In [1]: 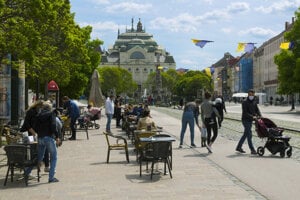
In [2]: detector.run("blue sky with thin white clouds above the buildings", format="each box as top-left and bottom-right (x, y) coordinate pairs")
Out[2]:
(70, 0), (300, 70)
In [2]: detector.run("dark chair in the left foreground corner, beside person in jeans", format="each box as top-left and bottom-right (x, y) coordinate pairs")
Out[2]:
(4, 145), (40, 186)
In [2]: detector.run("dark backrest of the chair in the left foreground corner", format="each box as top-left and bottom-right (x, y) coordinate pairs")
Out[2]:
(4, 145), (30, 165)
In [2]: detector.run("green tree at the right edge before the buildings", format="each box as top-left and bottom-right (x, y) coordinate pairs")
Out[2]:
(274, 8), (300, 110)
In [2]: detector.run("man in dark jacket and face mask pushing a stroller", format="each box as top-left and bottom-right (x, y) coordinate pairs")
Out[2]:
(236, 89), (261, 154)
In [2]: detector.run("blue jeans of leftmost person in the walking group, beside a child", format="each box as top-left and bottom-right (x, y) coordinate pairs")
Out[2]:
(180, 111), (195, 145)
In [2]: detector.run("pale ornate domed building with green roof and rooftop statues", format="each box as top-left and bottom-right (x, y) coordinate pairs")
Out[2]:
(100, 19), (176, 95)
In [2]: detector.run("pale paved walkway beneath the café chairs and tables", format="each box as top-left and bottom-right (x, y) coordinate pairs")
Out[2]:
(0, 105), (300, 200)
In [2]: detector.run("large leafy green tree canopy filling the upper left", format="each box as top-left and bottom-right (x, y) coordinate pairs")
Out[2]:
(0, 0), (103, 98)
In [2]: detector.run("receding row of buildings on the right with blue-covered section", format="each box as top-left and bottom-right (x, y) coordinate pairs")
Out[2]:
(214, 18), (299, 102)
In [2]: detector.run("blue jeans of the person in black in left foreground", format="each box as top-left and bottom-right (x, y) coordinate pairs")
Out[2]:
(38, 136), (57, 181)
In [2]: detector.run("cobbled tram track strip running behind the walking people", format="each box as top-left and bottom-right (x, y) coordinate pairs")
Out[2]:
(153, 103), (300, 162)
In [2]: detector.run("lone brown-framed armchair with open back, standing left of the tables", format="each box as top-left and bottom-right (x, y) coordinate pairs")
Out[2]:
(103, 132), (129, 163)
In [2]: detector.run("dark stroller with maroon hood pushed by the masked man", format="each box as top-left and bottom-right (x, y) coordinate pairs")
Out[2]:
(255, 118), (292, 158)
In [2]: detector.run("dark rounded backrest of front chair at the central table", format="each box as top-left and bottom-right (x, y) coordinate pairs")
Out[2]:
(145, 141), (171, 160)
